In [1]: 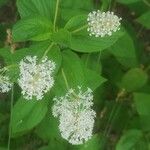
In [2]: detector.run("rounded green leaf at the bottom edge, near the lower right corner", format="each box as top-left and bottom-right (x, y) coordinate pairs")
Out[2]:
(116, 129), (143, 150)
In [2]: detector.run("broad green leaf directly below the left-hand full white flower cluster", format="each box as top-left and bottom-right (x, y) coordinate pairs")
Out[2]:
(11, 98), (48, 137)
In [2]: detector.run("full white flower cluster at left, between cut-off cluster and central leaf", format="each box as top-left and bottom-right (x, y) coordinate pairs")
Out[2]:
(18, 56), (55, 100)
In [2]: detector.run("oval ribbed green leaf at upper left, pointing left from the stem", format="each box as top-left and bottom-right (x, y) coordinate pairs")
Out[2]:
(13, 16), (53, 42)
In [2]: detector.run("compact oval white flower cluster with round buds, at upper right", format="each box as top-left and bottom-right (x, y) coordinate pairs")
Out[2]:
(87, 10), (121, 37)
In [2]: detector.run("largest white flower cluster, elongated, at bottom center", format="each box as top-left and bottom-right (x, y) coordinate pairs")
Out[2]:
(52, 87), (96, 145)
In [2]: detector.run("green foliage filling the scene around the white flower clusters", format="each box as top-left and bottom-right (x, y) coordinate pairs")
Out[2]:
(0, 0), (150, 150)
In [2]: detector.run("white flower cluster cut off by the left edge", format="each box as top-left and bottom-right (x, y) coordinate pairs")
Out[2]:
(0, 68), (12, 93)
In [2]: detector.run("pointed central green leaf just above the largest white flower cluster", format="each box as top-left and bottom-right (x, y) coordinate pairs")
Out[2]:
(55, 50), (106, 94)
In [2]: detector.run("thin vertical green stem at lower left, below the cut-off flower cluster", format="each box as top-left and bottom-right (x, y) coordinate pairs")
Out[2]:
(7, 85), (14, 150)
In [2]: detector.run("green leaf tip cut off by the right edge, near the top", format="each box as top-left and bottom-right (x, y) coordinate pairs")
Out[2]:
(136, 11), (150, 29)
